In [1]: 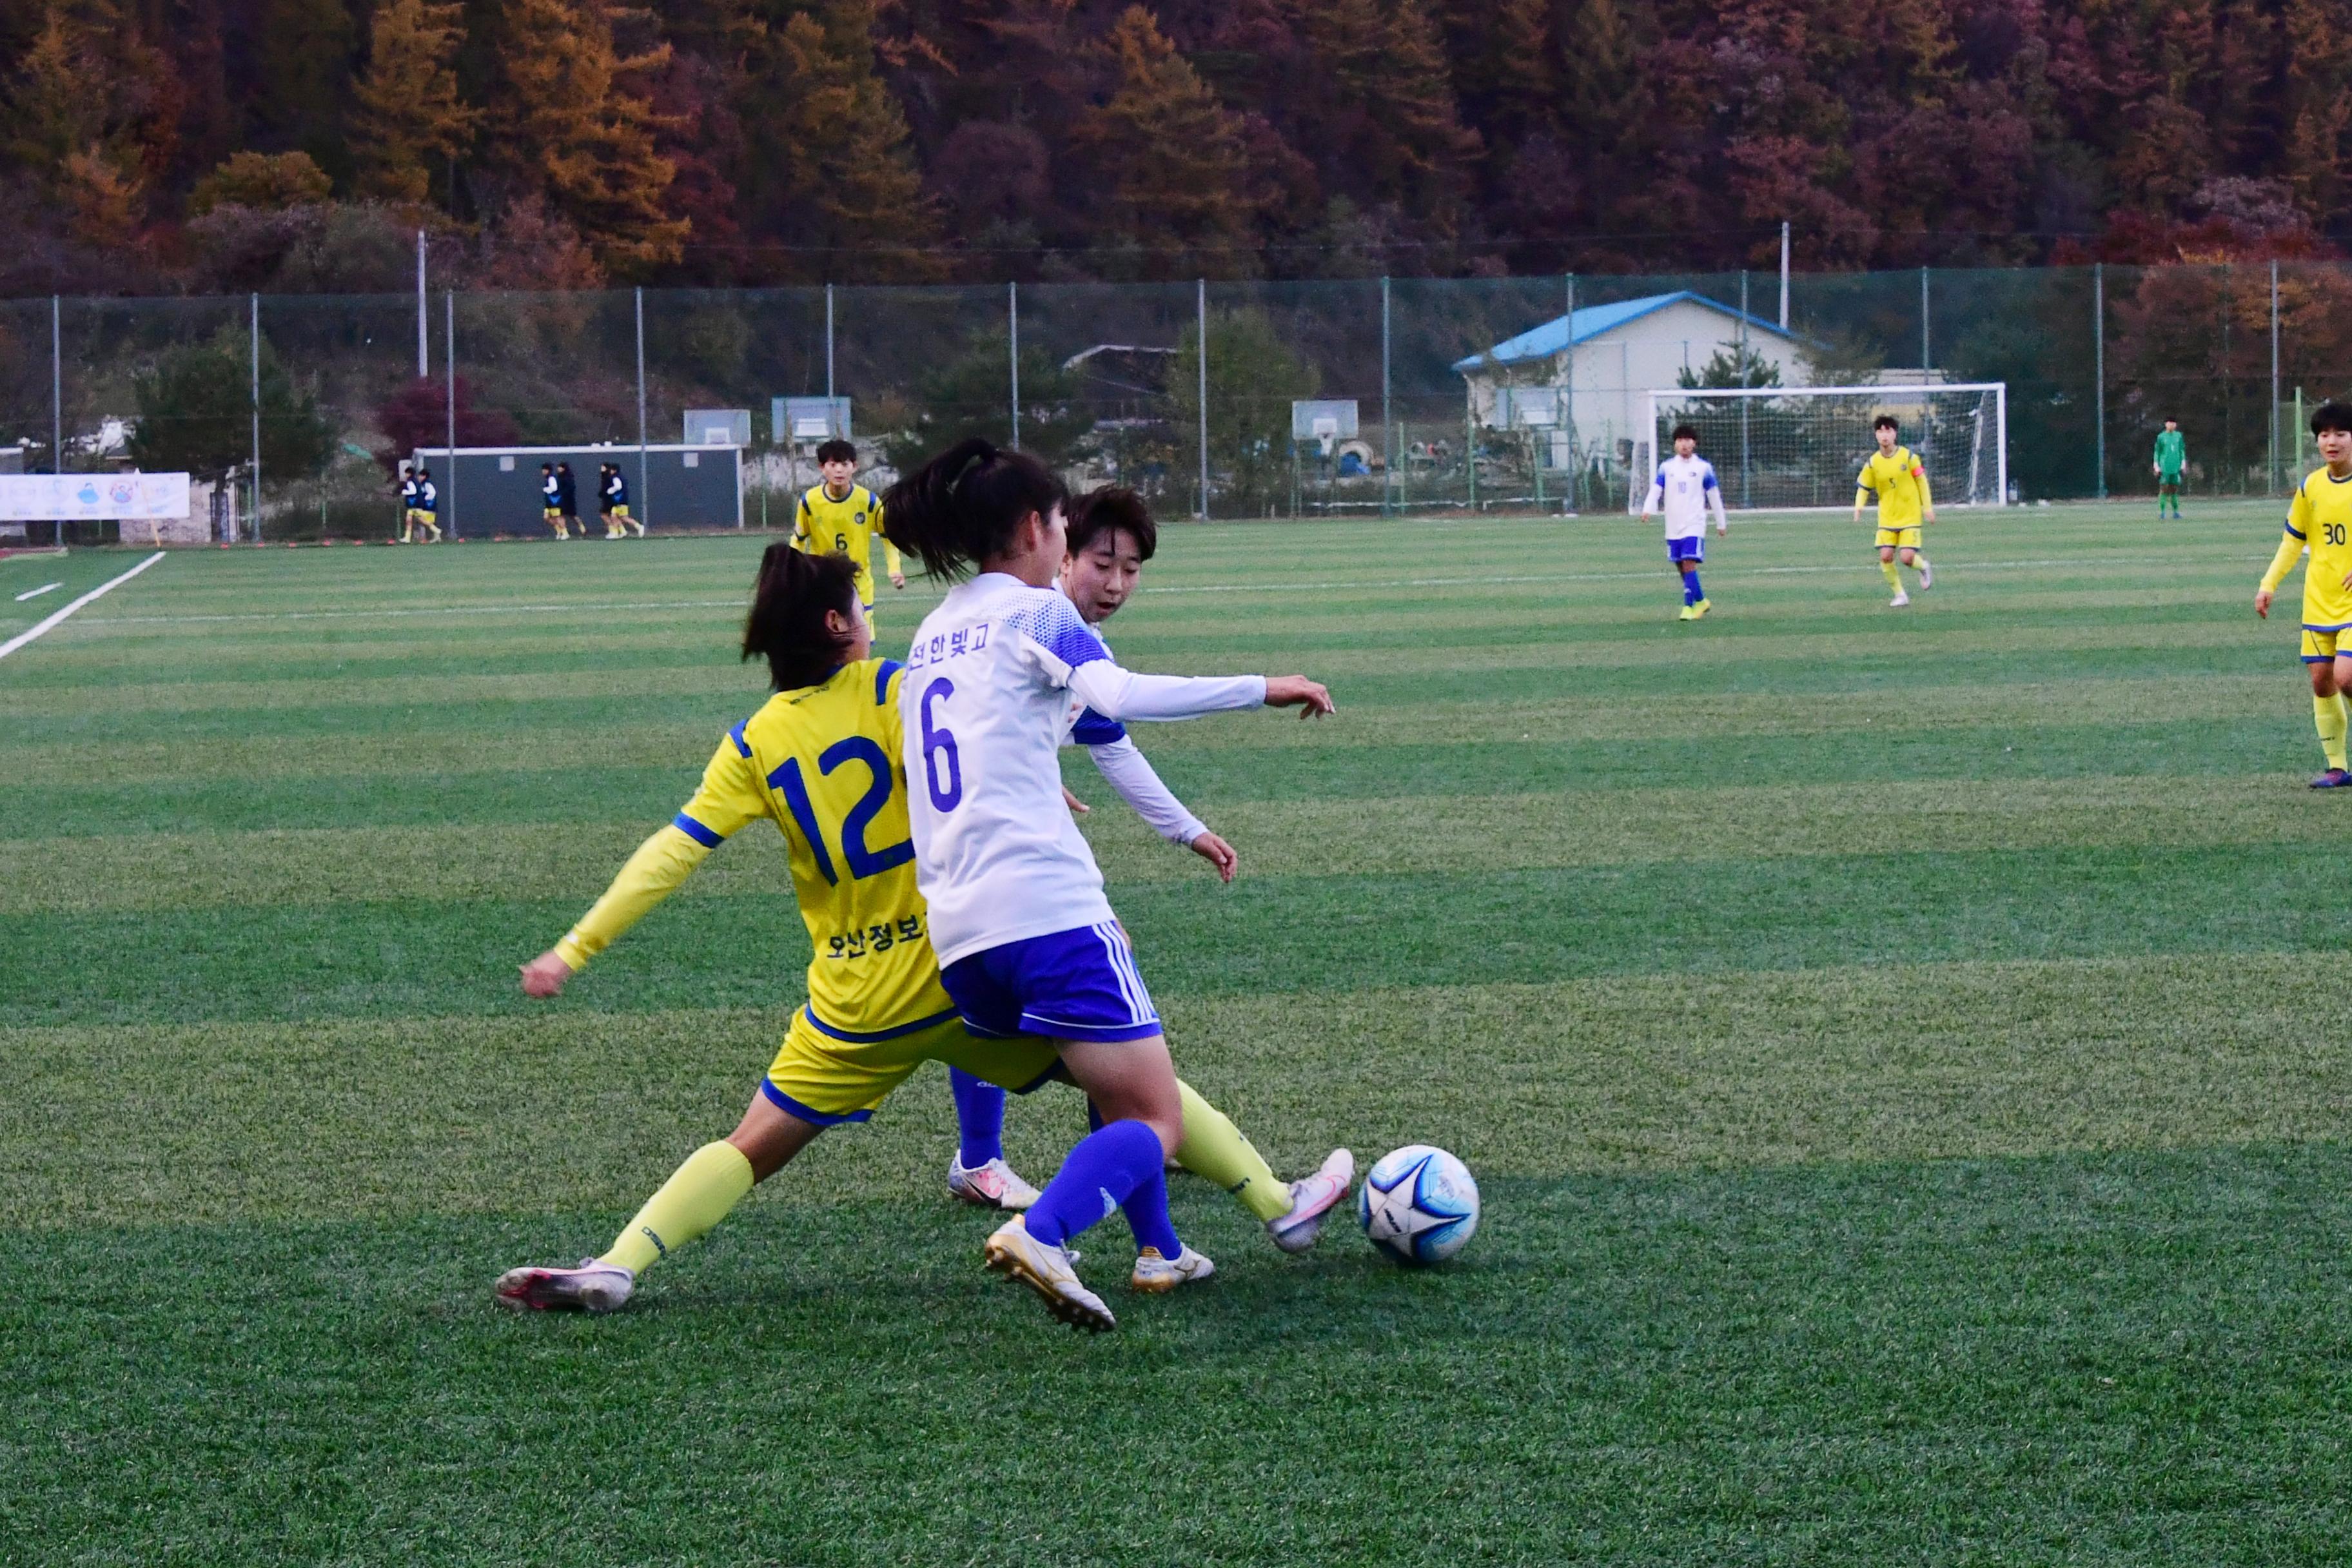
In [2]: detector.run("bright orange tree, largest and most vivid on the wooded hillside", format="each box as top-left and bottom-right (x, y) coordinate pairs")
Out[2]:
(496, 0), (692, 275)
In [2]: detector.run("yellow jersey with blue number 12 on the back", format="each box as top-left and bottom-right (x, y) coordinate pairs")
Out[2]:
(555, 658), (955, 1039)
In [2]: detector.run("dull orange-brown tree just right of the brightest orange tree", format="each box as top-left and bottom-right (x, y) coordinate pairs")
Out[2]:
(767, 0), (939, 277)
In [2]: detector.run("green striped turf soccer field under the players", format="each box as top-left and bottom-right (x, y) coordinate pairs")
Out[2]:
(0, 503), (2352, 1568)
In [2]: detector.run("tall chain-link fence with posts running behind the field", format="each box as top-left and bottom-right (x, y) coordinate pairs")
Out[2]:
(0, 263), (2352, 541)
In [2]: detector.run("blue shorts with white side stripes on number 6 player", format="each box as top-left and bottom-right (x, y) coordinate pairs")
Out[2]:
(939, 921), (1162, 1041)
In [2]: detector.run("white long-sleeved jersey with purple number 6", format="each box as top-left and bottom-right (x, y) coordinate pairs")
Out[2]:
(899, 571), (1266, 966)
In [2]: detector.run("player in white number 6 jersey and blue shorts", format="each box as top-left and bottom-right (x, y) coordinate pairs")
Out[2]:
(882, 440), (1353, 1331)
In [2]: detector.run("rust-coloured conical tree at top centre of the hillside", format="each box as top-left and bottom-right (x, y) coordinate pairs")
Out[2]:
(1072, 5), (1256, 275)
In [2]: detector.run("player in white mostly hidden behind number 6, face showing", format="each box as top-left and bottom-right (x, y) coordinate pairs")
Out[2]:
(948, 484), (1279, 1213)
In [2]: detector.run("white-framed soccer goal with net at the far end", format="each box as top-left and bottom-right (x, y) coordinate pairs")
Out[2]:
(1627, 381), (2008, 513)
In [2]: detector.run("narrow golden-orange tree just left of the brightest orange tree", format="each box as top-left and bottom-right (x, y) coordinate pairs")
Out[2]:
(353, 0), (478, 202)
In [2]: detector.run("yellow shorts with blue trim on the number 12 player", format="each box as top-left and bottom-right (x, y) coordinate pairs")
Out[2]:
(760, 1008), (1061, 1126)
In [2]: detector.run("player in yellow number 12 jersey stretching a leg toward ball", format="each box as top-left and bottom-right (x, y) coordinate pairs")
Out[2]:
(496, 543), (1336, 1312)
